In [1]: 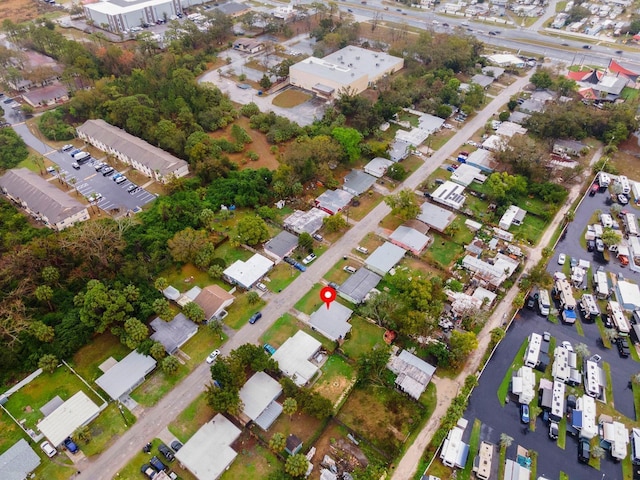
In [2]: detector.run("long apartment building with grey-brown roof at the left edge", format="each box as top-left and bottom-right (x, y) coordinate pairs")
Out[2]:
(0, 168), (89, 230)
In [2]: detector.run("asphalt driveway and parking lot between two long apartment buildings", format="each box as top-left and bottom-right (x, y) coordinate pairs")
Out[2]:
(0, 102), (156, 212)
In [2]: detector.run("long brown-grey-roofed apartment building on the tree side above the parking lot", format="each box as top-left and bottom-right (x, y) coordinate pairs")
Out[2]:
(77, 119), (189, 183)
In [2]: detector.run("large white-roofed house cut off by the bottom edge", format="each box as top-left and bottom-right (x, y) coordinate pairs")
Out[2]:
(176, 413), (242, 480)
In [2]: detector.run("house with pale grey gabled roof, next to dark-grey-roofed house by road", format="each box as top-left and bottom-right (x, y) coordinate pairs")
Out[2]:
(96, 350), (156, 400)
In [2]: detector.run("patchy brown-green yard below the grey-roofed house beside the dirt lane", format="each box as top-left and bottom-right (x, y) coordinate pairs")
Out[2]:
(338, 386), (425, 458)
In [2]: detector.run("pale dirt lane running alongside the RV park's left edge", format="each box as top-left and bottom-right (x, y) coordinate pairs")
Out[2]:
(391, 149), (602, 480)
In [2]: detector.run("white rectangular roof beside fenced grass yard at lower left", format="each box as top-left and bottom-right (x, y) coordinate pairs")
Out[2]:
(38, 391), (100, 447)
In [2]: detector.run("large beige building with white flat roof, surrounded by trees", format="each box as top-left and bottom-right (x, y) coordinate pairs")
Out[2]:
(289, 46), (404, 98)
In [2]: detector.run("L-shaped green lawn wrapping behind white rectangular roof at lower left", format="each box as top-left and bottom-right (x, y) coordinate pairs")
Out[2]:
(4, 366), (102, 429)
